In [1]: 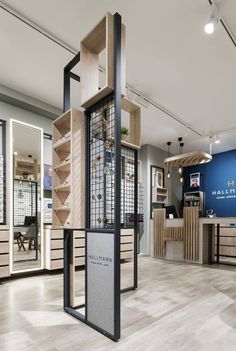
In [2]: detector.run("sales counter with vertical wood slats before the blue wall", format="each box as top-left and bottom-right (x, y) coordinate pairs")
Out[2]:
(150, 207), (236, 264)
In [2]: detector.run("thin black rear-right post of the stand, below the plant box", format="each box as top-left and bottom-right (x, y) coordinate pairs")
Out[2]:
(134, 150), (138, 289)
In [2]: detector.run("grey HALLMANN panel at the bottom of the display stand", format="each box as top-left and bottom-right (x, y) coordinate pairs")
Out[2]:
(87, 232), (114, 334)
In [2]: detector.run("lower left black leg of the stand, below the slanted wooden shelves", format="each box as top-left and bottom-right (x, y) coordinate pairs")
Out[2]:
(63, 229), (72, 309)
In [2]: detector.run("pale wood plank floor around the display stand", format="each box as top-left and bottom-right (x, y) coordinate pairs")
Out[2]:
(0, 257), (236, 351)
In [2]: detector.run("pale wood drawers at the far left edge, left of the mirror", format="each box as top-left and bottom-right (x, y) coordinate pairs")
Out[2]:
(0, 228), (10, 279)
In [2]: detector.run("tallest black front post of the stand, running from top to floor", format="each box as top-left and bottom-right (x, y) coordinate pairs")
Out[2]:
(114, 13), (121, 340)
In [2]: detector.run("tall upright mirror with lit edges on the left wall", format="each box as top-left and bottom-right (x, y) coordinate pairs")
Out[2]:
(10, 120), (43, 273)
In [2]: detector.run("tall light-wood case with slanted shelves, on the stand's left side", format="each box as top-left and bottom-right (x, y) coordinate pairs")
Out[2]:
(52, 109), (85, 228)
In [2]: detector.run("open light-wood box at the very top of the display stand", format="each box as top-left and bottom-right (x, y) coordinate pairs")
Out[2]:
(80, 12), (126, 108)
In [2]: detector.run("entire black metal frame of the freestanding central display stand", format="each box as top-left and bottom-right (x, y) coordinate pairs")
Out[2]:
(63, 13), (138, 341)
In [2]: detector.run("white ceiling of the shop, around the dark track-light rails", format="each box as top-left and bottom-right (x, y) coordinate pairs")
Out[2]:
(0, 0), (236, 152)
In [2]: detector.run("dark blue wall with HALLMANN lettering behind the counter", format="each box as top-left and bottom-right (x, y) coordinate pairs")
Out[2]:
(184, 150), (236, 217)
